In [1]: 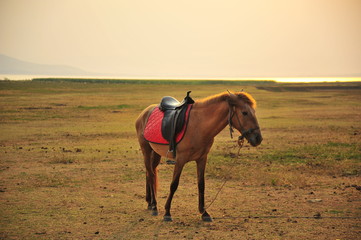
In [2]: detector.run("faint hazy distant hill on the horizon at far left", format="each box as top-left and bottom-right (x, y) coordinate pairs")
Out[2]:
(0, 54), (94, 76)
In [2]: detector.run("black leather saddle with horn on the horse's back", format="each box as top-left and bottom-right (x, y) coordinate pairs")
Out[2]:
(159, 91), (194, 157)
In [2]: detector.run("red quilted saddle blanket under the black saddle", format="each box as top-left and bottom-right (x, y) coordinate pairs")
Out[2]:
(143, 104), (192, 144)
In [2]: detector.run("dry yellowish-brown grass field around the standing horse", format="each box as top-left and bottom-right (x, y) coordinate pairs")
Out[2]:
(0, 81), (361, 239)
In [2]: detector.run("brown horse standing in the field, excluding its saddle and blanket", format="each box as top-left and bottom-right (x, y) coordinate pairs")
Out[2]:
(136, 92), (262, 221)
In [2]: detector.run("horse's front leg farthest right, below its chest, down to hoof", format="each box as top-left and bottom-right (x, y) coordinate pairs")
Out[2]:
(197, 158), (213, 222)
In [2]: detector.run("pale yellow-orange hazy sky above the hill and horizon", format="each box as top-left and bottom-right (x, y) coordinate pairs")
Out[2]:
(0, 0), (361, 78)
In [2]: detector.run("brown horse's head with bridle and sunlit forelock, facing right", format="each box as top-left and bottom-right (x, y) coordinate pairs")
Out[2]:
(228, 92), (263, 147)
